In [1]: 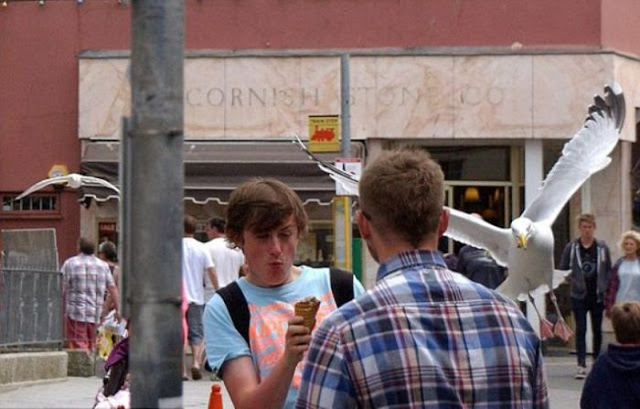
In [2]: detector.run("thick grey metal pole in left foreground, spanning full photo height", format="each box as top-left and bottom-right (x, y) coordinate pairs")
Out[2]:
(124, 0), (184, 408)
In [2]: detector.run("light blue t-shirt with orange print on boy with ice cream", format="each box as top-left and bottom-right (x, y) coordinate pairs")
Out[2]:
(203, 266), (364, 408)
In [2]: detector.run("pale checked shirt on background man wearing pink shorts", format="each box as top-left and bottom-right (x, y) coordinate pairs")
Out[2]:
(62, 254), (114, 324)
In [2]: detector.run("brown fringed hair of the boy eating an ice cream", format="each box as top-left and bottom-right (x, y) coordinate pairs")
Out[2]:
(226, 178), (308, 244)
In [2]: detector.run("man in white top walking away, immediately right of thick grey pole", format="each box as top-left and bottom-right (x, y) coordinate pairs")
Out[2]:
(182, 215), (218, 380)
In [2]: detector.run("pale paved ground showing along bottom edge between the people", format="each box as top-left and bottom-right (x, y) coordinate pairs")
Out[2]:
(0, 354), (584, 409)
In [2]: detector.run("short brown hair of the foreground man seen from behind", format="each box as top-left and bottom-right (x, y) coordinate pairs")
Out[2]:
(359, 147), (444, 248)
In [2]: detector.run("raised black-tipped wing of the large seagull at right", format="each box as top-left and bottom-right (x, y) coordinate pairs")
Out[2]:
(522, 83), (625, 225)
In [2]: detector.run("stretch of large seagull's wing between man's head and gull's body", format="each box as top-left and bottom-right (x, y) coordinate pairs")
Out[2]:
(444, 208), (513, 266)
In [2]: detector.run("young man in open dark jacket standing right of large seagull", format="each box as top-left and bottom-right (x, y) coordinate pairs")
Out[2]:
(558, 213), (611, 379)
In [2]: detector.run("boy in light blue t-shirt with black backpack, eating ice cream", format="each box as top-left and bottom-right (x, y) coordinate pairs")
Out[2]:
(204, 179), (364, 409)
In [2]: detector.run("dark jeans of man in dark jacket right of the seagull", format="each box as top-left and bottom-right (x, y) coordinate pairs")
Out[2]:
(571, 297), (604, 366)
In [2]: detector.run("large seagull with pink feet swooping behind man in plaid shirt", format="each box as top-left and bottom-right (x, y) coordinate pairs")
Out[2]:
(297, 83), (625, 341)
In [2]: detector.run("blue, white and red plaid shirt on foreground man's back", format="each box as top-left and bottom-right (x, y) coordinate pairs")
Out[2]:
(296, 251), (549, 409)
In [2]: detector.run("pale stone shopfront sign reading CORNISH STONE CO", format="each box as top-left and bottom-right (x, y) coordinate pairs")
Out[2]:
(78, 55), (605, 140)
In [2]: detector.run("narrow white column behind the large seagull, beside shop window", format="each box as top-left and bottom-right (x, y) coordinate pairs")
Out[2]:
(524, 139), (546, 336)
